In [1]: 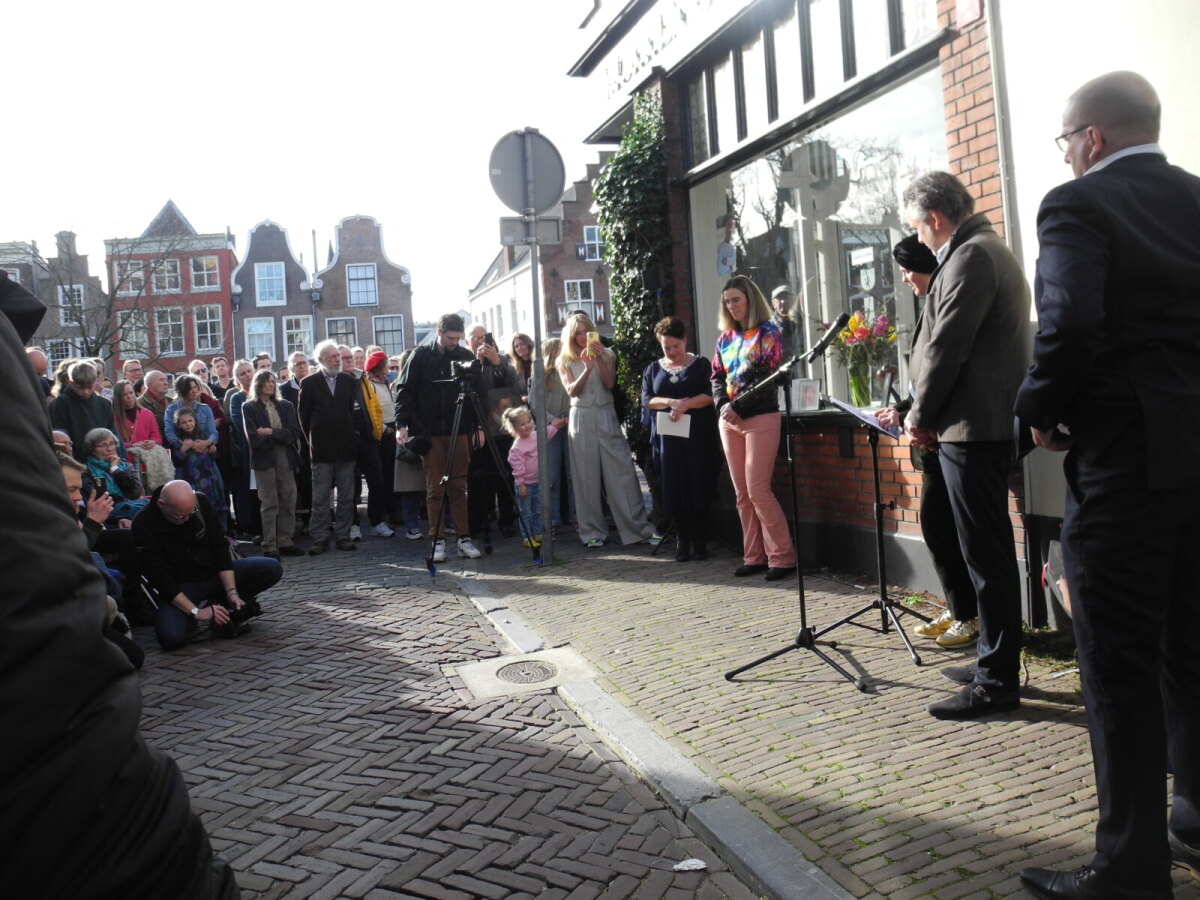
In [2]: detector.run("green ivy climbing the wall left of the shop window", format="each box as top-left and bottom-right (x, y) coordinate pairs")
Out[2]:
(593, 92), (674, 469)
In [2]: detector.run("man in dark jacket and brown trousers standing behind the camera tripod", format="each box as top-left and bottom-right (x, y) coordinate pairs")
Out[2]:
(396, 313), (486, 563)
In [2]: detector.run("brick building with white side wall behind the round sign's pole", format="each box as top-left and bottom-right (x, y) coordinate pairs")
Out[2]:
(468, 155), (612, 349)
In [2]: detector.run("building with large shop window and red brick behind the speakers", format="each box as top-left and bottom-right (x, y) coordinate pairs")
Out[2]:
(571, 0), (1044, 619)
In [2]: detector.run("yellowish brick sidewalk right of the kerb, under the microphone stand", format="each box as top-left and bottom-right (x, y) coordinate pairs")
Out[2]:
(458, 540), (1200, 900)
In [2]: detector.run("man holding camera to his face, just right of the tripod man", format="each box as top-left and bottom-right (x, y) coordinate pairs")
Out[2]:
(467, 325), (521, 538)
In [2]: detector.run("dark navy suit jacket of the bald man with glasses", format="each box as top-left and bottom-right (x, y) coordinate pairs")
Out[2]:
(1016, 154), (1200, 487)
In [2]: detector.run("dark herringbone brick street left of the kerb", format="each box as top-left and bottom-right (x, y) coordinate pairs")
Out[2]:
(137, 535), (754, 900)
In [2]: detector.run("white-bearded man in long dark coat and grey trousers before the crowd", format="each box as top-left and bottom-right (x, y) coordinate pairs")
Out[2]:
(298, 341), (359, 556)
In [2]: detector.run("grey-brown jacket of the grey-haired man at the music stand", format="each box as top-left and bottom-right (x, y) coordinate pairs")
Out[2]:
(907, 214), (1030, 442)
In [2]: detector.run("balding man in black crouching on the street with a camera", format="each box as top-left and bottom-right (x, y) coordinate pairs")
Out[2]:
(133, 481), (283, 650)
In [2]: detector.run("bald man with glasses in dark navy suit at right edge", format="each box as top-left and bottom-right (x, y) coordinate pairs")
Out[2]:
(1016, 72), (1200, 900)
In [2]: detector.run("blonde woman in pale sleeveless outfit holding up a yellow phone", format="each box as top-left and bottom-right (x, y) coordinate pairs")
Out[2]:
(558, 312), (654, 550)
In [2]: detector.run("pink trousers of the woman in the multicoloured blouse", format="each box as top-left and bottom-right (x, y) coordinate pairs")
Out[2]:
(720, 413), (796, 569)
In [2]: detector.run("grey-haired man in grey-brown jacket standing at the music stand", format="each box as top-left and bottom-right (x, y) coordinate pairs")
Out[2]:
(904, 172), (1030, 719)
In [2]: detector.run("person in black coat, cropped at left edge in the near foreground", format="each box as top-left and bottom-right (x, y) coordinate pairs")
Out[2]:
(0, 272), (239, 900)
